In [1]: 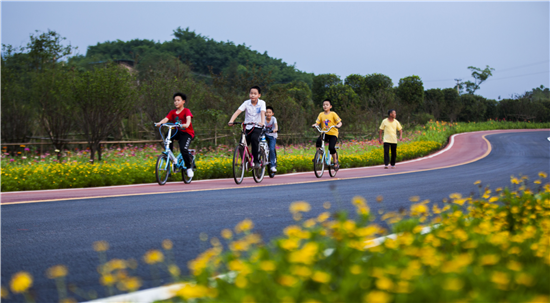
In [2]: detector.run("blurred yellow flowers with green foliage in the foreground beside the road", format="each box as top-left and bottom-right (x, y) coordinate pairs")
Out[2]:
(2, 177), (550, 303)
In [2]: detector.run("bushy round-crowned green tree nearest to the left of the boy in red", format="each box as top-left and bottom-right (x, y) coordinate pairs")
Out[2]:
(73, 63), (136, 163)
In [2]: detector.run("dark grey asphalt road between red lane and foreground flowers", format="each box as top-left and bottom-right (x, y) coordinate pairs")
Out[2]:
(1, 132), (550, 302)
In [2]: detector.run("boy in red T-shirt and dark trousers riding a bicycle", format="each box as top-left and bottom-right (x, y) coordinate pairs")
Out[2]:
(155, 93), (195, 178)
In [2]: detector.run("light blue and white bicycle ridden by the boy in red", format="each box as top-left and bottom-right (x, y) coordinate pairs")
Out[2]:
(155, 123), (196, 185)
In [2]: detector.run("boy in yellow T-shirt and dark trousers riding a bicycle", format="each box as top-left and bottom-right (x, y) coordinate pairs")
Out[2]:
(312, 99), (342, 169)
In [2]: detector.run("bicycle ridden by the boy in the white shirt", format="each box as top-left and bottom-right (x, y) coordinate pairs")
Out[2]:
(233, 122), (267, 184)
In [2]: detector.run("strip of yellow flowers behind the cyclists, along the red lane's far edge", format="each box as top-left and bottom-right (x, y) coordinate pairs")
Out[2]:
(1, 121), (550, 192)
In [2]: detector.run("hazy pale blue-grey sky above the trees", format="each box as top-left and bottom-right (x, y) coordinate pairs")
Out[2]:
(1, 1), (550, 99)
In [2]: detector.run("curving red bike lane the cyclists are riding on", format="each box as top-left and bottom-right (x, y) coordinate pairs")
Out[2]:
(0, 129), (550, 205)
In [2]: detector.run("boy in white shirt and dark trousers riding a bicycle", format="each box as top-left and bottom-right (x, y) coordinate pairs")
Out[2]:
(228, 86), (265, 168)
